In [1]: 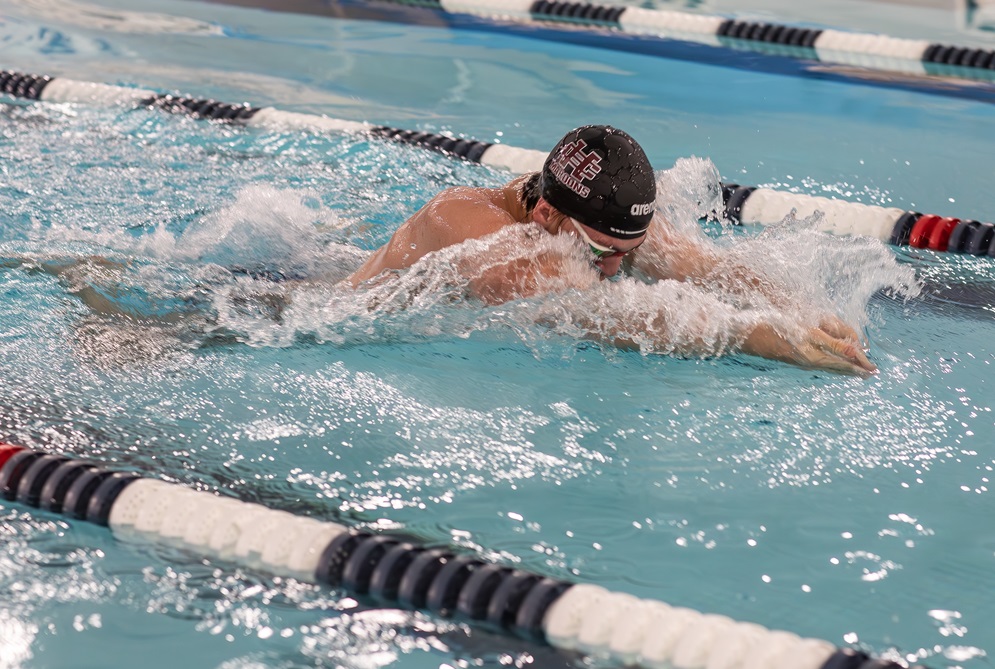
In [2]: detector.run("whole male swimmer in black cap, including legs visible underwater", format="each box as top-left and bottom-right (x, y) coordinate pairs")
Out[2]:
(0, 125), (876, 376)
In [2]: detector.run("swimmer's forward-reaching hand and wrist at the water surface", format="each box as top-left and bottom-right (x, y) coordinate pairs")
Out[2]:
(742, 324), (877, 378)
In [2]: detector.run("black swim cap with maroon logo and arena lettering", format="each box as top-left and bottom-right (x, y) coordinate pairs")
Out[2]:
(542, 125), (656, 239)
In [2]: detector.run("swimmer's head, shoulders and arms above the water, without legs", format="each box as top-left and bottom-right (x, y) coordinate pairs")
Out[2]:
(346, 125), (877, 376)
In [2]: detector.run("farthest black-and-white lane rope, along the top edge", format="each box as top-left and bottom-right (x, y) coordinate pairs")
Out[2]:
(335, 0), (995, 82)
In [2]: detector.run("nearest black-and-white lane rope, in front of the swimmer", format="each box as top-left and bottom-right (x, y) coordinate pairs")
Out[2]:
(0, 443), (922, 669)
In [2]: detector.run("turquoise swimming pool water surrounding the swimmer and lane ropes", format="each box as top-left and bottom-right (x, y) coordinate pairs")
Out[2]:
(0, 2), (995, 667)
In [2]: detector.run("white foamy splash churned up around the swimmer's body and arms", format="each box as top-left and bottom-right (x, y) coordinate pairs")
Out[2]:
(5, 172), (915, 357)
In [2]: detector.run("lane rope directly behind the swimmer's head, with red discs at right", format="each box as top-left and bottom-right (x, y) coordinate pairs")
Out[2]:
(0, 71), (995, 256)
